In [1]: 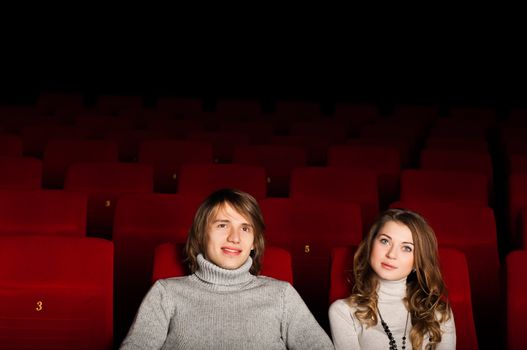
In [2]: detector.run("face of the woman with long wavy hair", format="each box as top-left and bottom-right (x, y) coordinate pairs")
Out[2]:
(370, 221), (414, 281)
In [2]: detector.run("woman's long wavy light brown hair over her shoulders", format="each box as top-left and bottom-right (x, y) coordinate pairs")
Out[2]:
(348, 209), (451, 349)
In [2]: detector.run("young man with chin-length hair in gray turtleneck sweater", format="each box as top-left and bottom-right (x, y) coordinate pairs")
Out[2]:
(121, 189), (333, 349)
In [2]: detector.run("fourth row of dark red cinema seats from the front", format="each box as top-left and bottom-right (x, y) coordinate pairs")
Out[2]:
(0, 137), (492, 196)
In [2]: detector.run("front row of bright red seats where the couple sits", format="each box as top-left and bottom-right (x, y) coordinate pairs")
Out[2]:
(0, 232), (527, 350)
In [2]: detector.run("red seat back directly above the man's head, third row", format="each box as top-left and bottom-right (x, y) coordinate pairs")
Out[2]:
(178, 164), (267, 199)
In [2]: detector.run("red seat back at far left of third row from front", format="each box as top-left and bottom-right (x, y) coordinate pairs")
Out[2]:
(0, 156), (42, 189)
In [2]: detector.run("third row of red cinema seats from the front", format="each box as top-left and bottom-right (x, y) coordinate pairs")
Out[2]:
(0, 154), (496, 233)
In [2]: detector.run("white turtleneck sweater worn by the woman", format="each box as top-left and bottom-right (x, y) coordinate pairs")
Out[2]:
(329, 278), (456, 350)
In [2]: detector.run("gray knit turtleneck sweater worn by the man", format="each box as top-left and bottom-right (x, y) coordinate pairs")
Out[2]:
(121, 255), (333, 349)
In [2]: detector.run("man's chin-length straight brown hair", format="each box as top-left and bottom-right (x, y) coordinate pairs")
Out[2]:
(185, 188), (265, 275)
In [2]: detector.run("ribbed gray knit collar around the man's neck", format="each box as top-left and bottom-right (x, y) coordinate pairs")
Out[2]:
(194, 254), (256, 286)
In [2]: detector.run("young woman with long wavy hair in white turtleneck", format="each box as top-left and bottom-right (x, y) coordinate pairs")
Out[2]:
(329, 209), (456, 350)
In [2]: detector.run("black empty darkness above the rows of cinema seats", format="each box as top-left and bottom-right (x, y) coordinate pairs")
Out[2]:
(0, 17), (527, 108)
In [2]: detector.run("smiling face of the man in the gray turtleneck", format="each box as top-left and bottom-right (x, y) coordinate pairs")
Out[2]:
(205, 204), (254, 270)
